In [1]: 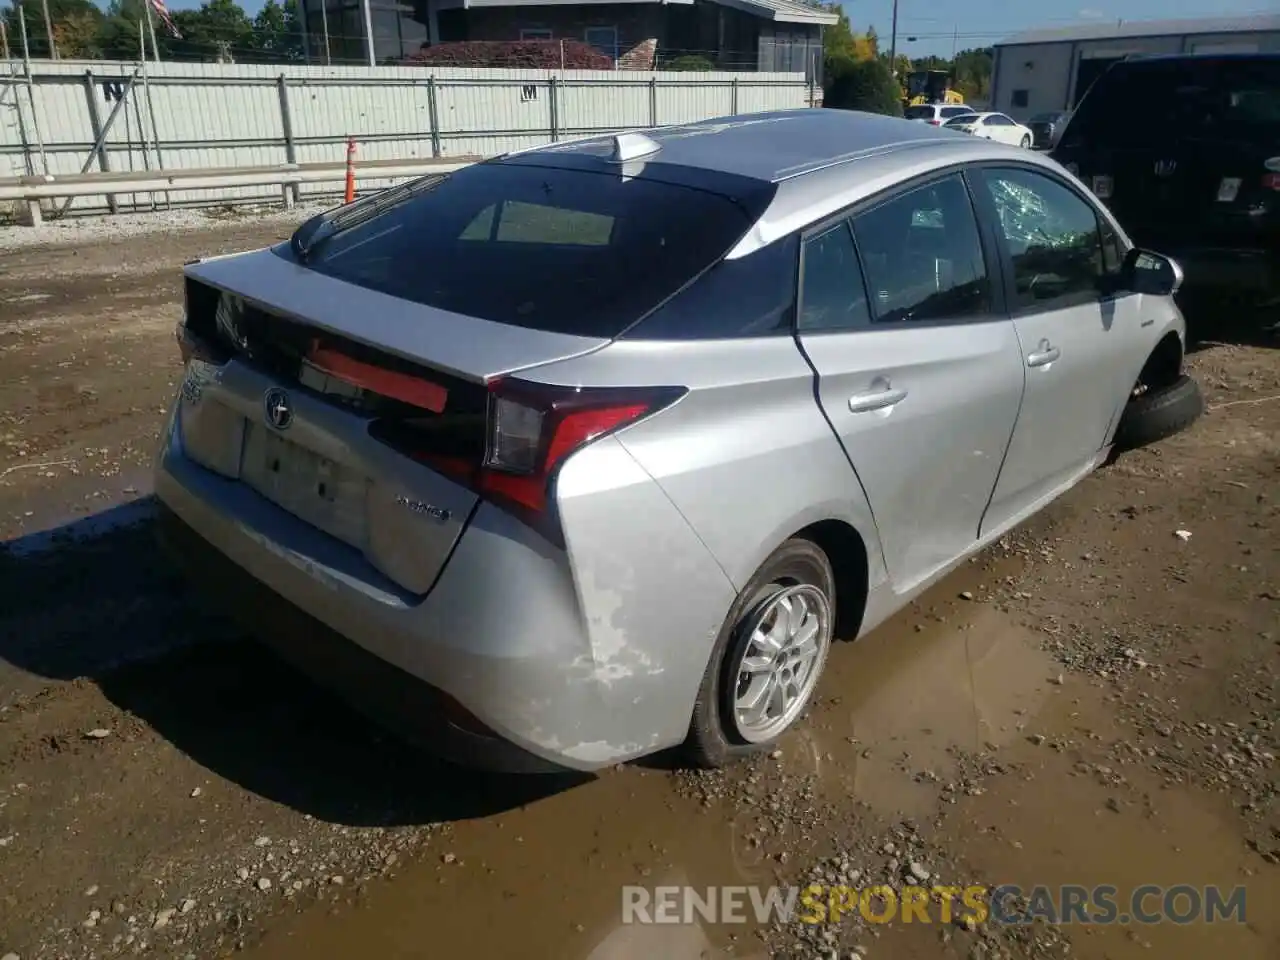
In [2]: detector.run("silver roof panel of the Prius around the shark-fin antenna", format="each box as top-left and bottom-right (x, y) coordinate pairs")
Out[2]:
(507, 108), (972, 183)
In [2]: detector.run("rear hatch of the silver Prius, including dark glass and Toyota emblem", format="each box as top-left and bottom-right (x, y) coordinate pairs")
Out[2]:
(179, 155), (773, 595)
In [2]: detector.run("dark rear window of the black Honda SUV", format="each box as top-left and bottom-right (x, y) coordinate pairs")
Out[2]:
(1064, 59), (1280, 147)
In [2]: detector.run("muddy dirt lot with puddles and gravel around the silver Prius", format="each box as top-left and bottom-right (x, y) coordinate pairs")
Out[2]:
(0, 218), (1280, 960)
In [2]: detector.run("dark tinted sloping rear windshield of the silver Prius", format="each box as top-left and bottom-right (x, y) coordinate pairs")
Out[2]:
(289, 163), (767, 338)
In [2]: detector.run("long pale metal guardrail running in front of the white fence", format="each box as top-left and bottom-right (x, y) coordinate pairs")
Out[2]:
(0, 156), (481, 227)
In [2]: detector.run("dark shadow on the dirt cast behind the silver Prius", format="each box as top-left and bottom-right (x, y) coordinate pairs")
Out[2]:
(0, 500), (590, 826)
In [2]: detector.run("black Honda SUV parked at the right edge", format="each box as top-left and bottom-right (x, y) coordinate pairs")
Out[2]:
(1051, 54), (1280, 316)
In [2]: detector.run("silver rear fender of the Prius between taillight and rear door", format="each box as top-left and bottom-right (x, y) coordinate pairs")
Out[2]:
(524, 337), (886, 632)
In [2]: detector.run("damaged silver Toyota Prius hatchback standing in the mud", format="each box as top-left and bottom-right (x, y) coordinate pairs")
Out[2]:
(156, 110), (1202, 771)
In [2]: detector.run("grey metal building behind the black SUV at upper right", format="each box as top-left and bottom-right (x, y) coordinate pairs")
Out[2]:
(991, 14), (1280, 120)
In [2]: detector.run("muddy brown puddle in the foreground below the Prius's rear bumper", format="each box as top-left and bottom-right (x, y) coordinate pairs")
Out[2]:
(251, 769), (771, 960)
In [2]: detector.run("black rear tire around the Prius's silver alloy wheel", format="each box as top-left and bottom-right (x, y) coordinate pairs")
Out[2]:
(685, 539), (836, 768)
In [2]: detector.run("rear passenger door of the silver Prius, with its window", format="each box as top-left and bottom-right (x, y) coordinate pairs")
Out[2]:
(797, 174), (1023, 591)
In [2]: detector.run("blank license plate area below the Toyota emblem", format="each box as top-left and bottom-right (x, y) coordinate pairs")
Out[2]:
(241, 422), (369, 549)
